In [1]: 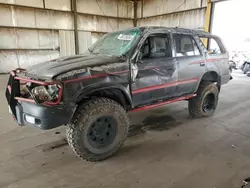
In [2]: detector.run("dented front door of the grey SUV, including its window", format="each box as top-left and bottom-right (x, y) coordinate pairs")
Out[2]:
(131, 33), (178, 107)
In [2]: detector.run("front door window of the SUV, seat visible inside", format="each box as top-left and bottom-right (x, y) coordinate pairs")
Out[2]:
(141, 34), (172, 59)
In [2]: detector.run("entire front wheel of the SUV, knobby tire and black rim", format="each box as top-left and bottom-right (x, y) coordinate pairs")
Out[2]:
(66, 98), (129, 162)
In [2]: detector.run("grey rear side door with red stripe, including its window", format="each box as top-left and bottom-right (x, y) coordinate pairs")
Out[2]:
(173, 34), (207, 96)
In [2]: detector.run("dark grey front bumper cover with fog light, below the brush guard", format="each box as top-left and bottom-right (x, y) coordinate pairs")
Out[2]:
(15, 101), (76, 130)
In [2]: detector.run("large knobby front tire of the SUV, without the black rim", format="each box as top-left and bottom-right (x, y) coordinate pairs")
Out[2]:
(66, 98), (129, 162)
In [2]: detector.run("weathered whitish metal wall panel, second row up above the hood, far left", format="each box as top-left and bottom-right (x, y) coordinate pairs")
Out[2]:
(0, 28), (59, 49)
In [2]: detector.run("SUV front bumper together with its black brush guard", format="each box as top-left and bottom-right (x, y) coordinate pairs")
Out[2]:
(5, 72), (76, 129)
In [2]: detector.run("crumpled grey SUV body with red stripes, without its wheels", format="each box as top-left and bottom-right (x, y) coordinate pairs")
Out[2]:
(6, 27), (231, 129)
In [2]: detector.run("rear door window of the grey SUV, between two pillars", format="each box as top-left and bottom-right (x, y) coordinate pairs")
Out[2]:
(174, 34), (201, 57)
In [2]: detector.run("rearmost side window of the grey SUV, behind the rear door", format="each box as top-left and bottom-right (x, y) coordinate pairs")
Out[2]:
(200, 37), (223, 55)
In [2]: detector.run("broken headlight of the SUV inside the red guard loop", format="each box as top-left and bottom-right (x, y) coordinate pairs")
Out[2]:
(31, 84), (59, 102)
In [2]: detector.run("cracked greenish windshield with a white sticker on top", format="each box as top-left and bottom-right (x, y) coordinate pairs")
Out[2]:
(89, 29), (141, 56)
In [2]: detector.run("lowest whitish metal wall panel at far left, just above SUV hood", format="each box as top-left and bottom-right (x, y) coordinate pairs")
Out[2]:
(0, 50), (59, 73)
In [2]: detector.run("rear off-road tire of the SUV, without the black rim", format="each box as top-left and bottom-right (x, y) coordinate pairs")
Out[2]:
(188, 82), (219, 118)
